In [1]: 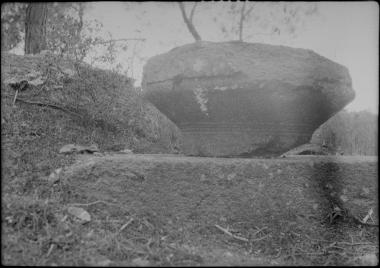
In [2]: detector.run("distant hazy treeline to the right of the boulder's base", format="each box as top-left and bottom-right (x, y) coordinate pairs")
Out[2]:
(311, 111), (378, 155)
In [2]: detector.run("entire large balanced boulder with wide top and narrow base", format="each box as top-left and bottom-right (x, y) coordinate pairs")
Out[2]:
(142, 41), (355, 157)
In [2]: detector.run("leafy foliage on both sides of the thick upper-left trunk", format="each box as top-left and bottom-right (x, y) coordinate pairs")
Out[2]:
(1, 2), (138, 76)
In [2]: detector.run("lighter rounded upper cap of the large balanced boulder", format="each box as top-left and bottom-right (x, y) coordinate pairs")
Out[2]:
(143, 41), (351, 87)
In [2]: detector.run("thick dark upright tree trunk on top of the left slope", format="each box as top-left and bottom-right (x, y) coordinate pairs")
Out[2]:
(25, 3), (47, 54)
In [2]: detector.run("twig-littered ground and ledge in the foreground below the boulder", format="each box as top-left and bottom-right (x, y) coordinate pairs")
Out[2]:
(2, 153), (379, 266)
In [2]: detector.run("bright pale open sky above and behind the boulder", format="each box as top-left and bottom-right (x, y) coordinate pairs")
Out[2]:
(11, 1), (379, 113)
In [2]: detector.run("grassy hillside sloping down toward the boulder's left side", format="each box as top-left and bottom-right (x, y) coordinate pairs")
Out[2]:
(1, 53), (179, 197)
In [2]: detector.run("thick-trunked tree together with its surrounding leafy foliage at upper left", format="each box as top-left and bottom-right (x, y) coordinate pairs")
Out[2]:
(1, 2), (145, 74)
